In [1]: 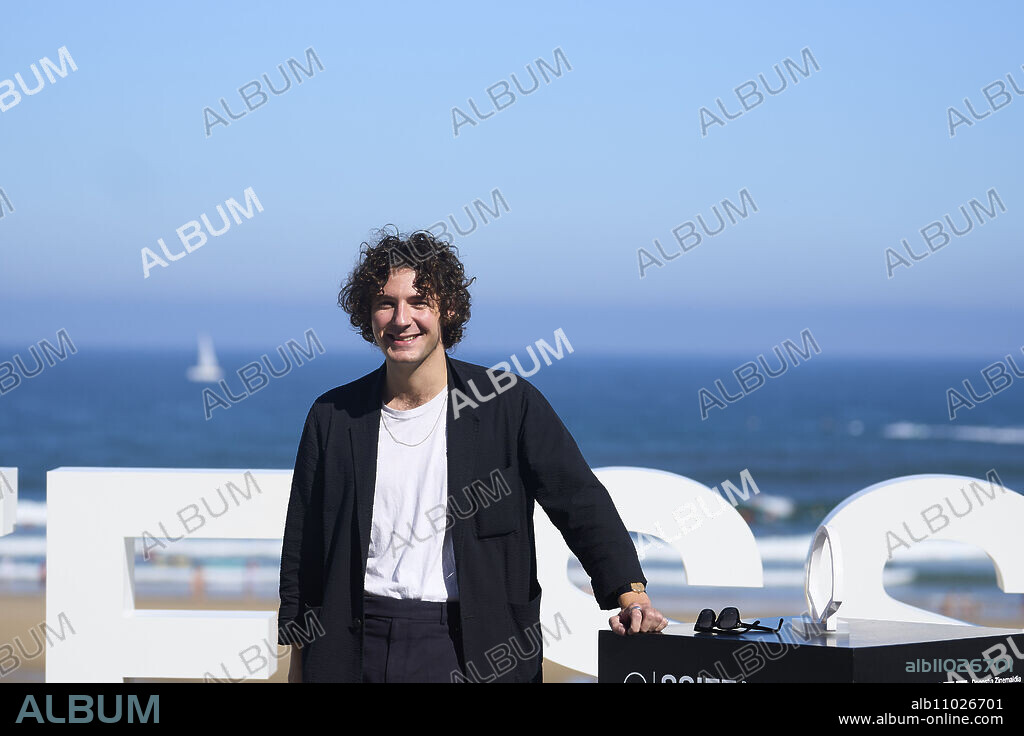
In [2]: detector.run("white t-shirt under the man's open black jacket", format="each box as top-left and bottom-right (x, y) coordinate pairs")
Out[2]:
(364, 386), (459, 601)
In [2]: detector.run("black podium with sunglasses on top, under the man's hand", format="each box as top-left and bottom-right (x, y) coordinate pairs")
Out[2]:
(597, 616), (1024, 684)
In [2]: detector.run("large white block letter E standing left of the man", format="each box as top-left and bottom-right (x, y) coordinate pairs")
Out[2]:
(46, 468), (292, 683)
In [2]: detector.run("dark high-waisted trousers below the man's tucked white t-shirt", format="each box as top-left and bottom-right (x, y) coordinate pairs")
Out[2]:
(362, 594), (465, 683)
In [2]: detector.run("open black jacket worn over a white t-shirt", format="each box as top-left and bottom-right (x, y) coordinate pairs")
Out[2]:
(278, 354), (646, 682)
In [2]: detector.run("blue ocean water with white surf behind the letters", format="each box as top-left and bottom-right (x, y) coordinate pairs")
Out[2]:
(0, 347), (1024, 618)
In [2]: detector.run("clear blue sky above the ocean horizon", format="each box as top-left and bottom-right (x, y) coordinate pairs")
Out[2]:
(0, 2), (1024, 359)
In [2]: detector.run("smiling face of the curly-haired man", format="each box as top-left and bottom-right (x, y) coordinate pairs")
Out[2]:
(370, 268), (444, 364)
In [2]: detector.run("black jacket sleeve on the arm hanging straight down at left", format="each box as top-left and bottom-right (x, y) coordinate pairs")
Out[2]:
(278, 403), (324, 645)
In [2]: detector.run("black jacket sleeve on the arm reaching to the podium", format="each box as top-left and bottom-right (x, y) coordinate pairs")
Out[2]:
(518, 379), (647, 609)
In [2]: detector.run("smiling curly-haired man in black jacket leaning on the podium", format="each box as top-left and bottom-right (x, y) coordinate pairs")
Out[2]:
(279, 228), (668, 682)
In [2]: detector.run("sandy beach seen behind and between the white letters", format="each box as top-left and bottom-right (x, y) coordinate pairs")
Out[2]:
(0, 592), (1021, 683)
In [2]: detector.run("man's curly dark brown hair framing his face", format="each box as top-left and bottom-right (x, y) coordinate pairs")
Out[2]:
(338, 225), (476, 349)
